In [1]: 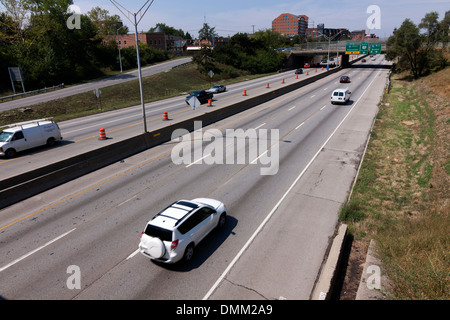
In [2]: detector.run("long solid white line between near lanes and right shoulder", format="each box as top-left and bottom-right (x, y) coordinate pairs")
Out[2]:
(202, 71), (381, 300)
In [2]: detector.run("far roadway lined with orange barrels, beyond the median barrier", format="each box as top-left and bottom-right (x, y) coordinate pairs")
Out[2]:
(0, 65), (330, 179)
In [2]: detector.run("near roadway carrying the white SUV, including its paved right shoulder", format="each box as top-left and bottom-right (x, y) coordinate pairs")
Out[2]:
(0, 56), (387, 300)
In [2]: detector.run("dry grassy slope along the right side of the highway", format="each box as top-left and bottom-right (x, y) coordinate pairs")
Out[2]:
(340, 68), (450, 300)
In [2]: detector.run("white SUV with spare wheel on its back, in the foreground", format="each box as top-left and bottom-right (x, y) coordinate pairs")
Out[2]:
(139, 198), (226, 263)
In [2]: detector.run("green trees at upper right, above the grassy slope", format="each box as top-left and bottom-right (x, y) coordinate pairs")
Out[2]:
(386, 12), (450, 79)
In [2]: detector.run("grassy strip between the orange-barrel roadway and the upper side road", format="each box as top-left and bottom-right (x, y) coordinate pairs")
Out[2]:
(0, 64), (261, 127)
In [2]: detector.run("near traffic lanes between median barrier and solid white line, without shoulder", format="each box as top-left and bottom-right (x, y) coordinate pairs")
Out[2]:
(0, 55), (388, 299)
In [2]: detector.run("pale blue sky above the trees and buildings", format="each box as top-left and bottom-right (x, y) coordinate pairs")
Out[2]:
(73, 0), (450, 38)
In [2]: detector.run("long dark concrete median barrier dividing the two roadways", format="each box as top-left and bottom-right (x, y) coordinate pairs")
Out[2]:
(0, 68), (341, 209)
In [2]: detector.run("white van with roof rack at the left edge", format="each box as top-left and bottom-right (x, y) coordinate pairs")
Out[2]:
(0, 119), (62, 158)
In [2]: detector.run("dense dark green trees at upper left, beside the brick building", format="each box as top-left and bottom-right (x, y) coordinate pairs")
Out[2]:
(0, 0), (168, 92)
